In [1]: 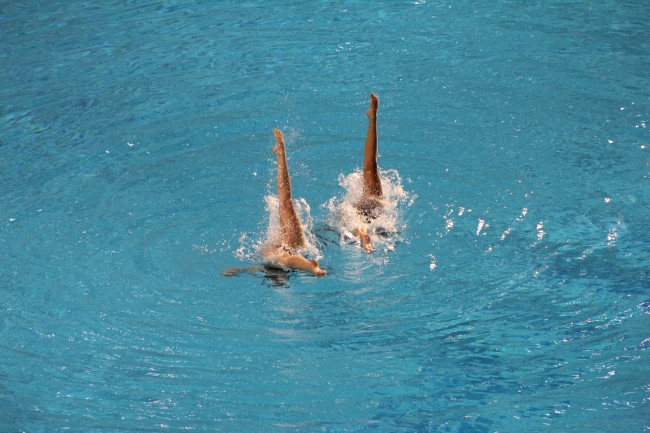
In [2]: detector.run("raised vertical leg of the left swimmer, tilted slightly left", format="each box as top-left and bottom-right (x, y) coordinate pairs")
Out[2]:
(273, 129), (306, 249)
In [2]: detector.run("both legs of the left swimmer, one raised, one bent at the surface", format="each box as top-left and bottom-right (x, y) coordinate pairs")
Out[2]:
(264, 129), (325, 275)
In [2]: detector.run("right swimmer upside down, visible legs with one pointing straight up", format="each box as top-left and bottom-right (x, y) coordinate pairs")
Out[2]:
(354, 93), (384, 252)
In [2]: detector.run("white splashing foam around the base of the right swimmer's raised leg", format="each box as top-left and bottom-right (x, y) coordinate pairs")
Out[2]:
(325, 170), (416, 250)
